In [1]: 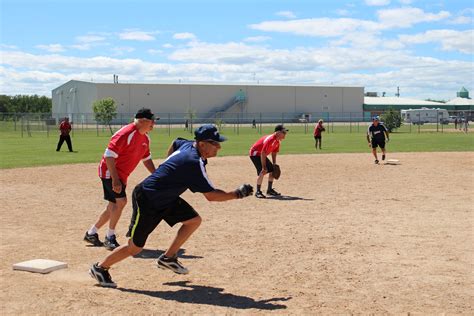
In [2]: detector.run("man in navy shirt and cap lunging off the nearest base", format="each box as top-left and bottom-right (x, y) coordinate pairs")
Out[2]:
(89, 125), (253, 287)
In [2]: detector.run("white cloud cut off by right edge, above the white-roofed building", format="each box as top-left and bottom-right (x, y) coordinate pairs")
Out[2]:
(399, 29), (474, 54)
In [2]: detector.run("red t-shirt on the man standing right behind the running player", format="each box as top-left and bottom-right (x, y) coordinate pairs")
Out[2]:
(99, 123), (151, 184)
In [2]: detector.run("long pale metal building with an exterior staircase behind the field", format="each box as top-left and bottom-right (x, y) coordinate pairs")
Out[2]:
(52, 80), (364, 121)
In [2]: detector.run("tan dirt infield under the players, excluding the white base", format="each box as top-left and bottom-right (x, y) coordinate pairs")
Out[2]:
(0, 152), (474, 315)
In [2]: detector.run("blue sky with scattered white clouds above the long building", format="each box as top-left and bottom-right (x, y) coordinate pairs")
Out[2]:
(0, 0), (474, 100)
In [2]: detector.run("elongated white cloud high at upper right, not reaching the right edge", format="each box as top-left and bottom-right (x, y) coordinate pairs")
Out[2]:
(377, 7), (451, 29)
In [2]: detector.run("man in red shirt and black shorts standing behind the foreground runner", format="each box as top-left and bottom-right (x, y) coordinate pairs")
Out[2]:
(84, 108), (155, 250)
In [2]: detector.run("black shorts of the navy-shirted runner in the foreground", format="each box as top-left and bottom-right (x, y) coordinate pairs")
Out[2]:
(130, 185), (199, 248)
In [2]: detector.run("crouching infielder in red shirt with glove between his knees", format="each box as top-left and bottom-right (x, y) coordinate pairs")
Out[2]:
(249, 124), (289, 199)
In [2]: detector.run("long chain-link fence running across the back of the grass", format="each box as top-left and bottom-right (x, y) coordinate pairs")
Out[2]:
(0, 111), (474, 137)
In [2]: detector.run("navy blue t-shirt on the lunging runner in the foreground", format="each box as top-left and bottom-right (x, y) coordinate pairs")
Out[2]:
(140, 139), (215, 209)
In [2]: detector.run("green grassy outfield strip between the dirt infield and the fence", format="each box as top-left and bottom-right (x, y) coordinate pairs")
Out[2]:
(0, 123), (474, 169)
